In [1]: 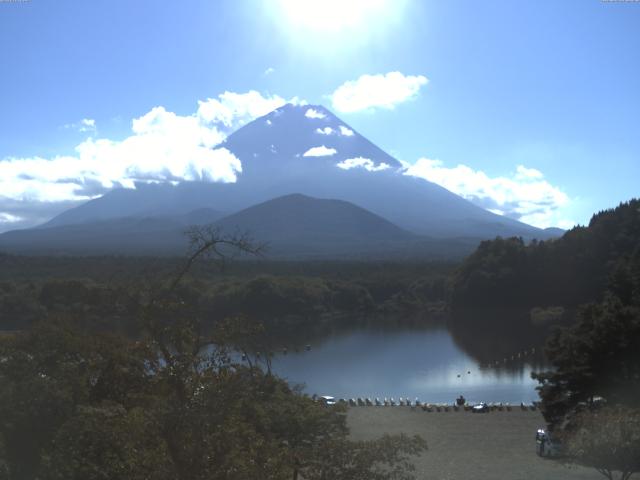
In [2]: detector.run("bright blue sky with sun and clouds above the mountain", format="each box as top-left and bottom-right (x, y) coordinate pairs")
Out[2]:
(0, 0), (640, 231)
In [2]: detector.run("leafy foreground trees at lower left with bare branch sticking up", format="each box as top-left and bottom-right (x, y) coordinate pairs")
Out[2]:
(0, 230), (426, 480)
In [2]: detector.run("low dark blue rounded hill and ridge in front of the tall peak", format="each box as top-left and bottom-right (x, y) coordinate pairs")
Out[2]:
(0, 194), (480, 260)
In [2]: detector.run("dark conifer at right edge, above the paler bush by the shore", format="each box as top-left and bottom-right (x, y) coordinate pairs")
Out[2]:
(533, 298), (640, 429)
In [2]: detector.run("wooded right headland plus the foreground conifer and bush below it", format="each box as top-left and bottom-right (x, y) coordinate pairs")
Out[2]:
(450, 199), (640, 480)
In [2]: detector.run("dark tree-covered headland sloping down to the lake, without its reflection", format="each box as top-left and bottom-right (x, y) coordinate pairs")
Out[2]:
(451, 200), (640, 309)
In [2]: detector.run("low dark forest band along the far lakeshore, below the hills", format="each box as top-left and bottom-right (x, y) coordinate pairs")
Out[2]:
(0, 257), (451, 336)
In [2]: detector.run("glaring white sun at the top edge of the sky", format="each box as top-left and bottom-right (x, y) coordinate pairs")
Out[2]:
(280, 0), (401, 32)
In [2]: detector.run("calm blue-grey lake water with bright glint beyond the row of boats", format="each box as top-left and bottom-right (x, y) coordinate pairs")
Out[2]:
(273, 328), (537, 403)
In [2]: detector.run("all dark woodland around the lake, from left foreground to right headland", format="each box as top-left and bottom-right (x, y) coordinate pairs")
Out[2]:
(0, 200), (640, 480)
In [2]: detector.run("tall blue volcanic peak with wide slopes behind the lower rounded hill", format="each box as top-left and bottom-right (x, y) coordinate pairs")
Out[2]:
(37, 105), (557, 240)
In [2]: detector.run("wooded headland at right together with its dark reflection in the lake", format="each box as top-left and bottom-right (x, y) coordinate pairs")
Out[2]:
(449, 200), (640, 362)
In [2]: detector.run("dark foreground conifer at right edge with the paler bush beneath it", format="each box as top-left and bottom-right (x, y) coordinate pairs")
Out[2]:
(534, 262), (640, 480)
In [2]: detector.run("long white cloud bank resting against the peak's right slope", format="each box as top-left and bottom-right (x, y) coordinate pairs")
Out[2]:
(405, 158), (574, 228)
